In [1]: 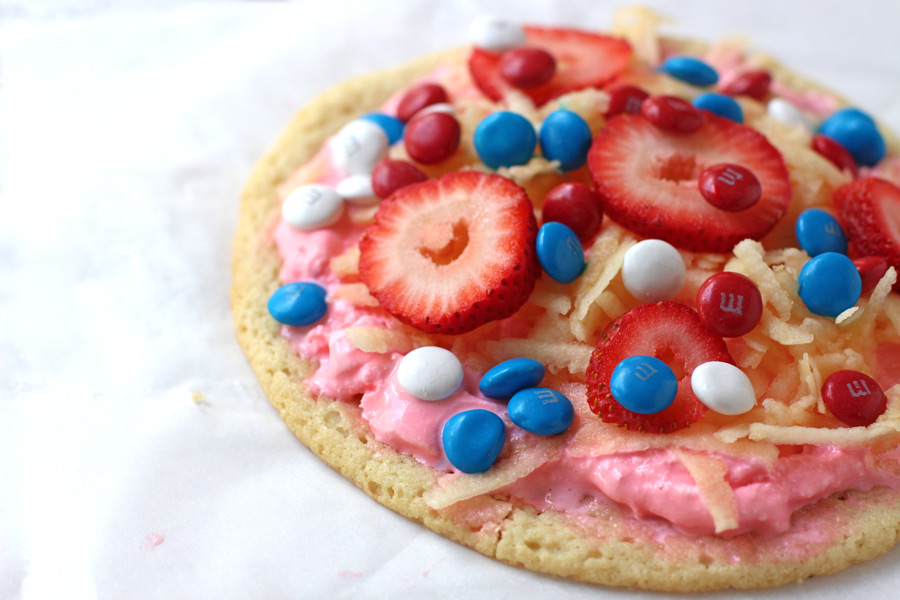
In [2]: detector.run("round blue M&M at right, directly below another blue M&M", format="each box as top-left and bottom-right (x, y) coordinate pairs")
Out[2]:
(799, 252), (862, 317)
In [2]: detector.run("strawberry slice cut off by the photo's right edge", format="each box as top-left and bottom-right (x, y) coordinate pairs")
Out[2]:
(834, 177), (900, 287)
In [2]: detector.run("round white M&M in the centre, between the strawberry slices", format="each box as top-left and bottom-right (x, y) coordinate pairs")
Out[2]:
(622, 240), (687, 302)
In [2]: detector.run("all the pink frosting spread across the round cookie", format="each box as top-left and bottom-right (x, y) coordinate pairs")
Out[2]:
(273, 57), (900, 535)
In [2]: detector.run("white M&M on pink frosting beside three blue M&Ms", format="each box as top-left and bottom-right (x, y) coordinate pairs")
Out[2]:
(397, 346), (463, 400)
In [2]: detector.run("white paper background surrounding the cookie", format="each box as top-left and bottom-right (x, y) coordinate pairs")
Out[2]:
(0, 0), (900, 600)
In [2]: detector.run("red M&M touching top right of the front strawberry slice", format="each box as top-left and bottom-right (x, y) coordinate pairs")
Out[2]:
(697, 271), (762, 337)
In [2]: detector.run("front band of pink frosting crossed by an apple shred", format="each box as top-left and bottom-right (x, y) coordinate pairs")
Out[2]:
(496, 446), (900, 536)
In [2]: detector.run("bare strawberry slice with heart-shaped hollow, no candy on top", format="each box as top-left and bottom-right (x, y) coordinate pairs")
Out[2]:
(359, 171), (540, 334)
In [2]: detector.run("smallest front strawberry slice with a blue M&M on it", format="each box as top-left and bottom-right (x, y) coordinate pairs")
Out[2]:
(587, 302), (734, 433)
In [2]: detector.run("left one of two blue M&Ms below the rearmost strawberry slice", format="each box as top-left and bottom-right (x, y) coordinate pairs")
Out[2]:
(474, 111), (537, 169)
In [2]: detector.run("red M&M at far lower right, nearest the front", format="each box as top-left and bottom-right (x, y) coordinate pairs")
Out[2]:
(822, 369), (887, 427)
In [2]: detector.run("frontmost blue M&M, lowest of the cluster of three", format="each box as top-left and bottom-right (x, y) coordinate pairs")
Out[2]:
(441, 408), (506, 473)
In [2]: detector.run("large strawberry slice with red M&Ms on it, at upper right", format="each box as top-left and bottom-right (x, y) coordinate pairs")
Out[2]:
(588, 113), (791, 252)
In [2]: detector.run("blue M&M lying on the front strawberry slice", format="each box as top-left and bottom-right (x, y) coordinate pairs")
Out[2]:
(609, 355), (678, 415)
